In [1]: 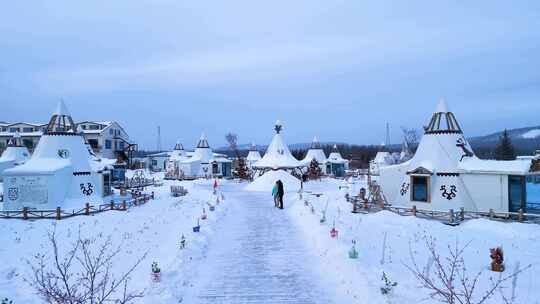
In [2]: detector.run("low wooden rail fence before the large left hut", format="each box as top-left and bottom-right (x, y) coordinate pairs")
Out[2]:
(0, 192), (154, 220)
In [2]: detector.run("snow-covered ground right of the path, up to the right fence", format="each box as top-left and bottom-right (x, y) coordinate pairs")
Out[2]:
(288, 180), (540, 303)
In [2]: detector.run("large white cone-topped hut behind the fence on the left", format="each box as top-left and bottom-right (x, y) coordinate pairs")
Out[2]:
(3, 101), (102, 210)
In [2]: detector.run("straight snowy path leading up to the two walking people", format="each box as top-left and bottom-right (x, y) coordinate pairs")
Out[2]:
(183, 186), (337, 303)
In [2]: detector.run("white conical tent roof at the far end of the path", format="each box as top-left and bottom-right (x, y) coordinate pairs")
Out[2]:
(253, 120), (304, 169)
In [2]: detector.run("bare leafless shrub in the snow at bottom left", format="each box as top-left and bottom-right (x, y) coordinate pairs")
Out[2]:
(25, 228), (147, 304)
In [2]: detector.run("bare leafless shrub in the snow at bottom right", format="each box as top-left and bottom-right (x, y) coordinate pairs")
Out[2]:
(405, 237), (531, 304)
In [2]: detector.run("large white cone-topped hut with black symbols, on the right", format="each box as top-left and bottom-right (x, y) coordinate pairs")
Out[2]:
(379, 101), (540, 212)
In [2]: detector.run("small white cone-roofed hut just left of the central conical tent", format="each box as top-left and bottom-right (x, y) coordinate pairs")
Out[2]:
(175, 134), (232, 178)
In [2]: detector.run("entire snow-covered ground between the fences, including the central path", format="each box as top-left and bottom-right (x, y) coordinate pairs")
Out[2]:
(0, 179), (540, 304)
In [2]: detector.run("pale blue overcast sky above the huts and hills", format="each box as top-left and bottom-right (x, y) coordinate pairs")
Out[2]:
(0, 0), (540, 149)
